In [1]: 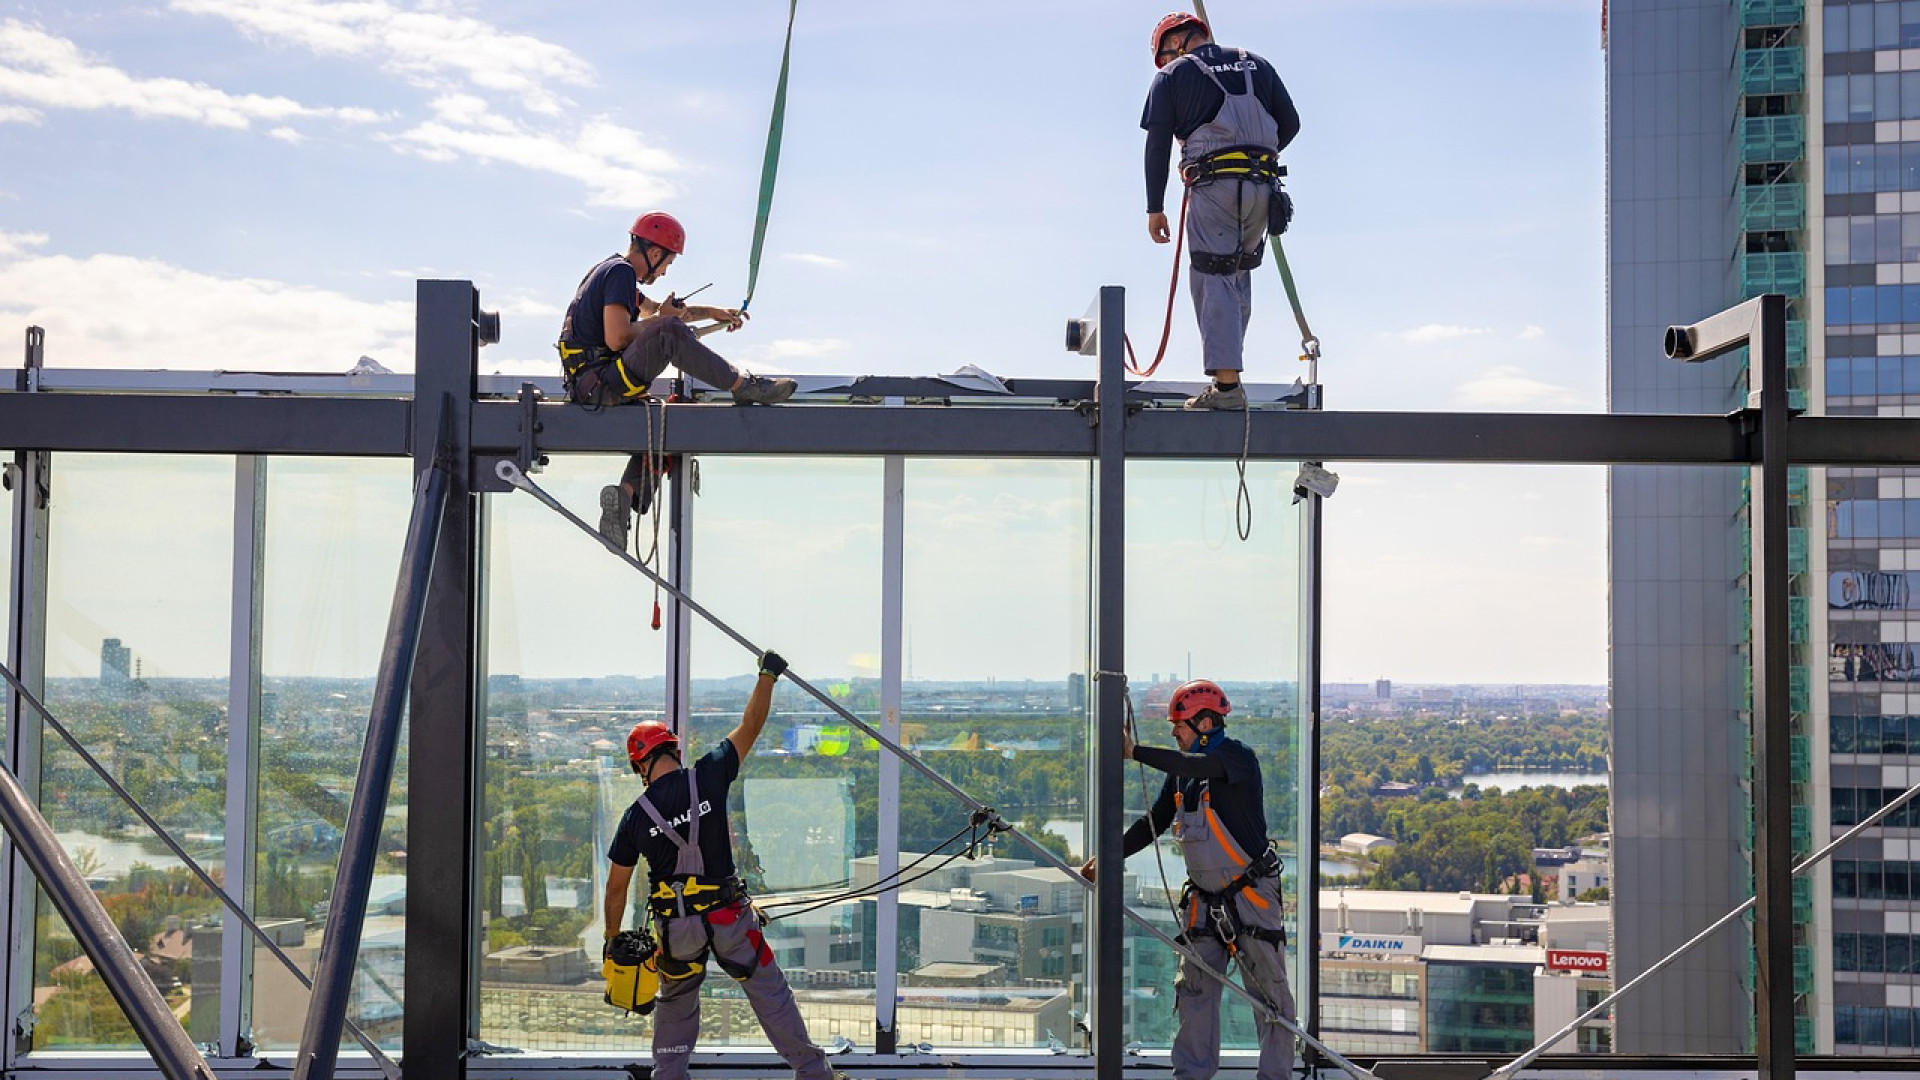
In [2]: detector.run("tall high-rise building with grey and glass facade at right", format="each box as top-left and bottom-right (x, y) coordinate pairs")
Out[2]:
(1603, 0), (1873, 1055)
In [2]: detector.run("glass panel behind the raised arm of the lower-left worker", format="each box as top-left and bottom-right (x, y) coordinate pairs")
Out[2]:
(683, 457), (883, 1045)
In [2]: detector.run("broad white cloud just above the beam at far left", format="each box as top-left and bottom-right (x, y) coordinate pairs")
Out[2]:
(0, 233), (413, 371)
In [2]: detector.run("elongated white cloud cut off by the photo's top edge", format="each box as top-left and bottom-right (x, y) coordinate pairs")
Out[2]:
(171, 0), (593, 115)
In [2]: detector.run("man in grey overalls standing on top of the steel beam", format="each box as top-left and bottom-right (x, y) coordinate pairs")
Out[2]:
(1140, 12), (1300, 409)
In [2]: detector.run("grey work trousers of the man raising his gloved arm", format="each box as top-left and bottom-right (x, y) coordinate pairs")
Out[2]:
(653, 905), (833, 1080)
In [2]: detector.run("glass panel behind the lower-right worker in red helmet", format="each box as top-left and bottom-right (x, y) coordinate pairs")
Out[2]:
(1125, 461), (1315, 1049)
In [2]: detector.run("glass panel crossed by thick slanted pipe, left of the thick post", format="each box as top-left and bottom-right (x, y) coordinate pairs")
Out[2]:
(252, 457), (413, 1053)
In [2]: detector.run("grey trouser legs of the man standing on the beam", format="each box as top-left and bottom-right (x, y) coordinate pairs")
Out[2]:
(1187, 177), (1273, 375)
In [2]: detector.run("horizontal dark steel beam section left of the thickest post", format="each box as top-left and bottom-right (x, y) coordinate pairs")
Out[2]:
(0, 392), (413, 457)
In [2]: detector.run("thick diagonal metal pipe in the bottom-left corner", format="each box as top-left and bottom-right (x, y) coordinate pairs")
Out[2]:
(0, 687), (215, 1080)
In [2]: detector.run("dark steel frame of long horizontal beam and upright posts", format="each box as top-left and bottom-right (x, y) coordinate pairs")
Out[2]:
(0, 281), (1889, 1080)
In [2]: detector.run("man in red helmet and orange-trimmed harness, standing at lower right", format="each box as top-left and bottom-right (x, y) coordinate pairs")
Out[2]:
(1081, 678), (1294, 1080)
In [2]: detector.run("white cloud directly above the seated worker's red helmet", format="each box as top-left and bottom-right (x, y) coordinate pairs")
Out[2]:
(388, 94), (680, 206)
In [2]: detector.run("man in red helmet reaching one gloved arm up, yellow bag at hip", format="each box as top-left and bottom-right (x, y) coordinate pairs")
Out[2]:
(601, 651), (835, 1080)
